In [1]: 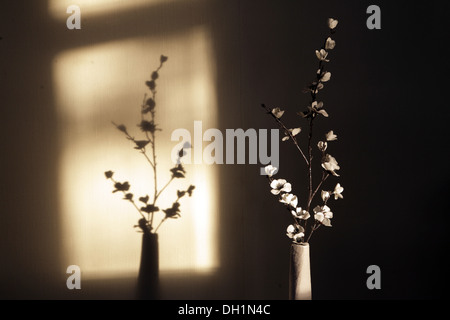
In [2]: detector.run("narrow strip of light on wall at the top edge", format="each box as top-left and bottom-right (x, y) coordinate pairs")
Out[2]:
(48, 0), (165, 19)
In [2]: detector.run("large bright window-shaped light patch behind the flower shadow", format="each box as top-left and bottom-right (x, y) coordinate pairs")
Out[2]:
(53, 28), (218, 278)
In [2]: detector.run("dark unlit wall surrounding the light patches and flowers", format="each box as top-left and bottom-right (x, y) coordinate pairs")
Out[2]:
(0, 0), (450, 299)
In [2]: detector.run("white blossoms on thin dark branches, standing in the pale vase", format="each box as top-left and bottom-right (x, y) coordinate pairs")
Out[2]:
(262, 18), (344, 243)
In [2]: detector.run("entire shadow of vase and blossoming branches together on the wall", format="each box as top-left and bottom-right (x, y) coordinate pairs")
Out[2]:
(105, 55), (195, 299)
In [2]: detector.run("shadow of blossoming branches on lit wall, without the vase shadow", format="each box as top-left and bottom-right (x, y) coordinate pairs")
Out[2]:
(105, 55), (195, 234)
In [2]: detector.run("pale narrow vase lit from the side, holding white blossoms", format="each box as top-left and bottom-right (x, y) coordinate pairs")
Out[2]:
(289, 243), (311, 300)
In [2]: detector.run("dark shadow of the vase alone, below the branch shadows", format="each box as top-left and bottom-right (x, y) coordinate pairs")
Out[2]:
(137, 232), (160, 300)
